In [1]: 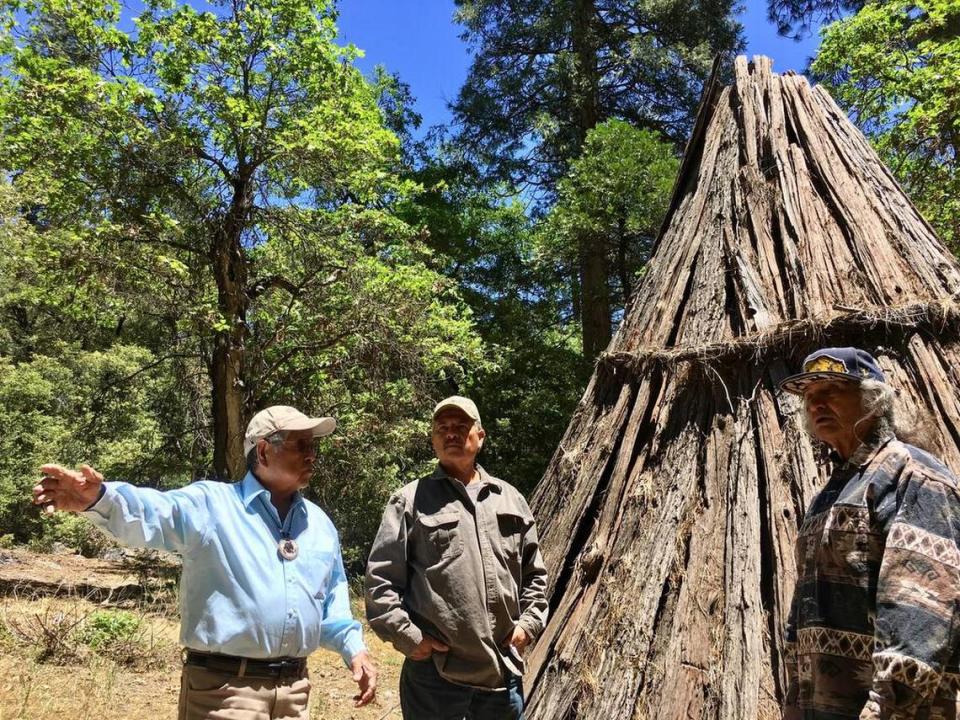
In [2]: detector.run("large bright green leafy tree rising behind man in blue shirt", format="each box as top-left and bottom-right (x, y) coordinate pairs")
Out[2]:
(0, 0), (436, 478)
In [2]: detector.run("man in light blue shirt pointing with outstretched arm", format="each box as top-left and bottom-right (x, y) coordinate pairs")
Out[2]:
(33, 406), (376, 720)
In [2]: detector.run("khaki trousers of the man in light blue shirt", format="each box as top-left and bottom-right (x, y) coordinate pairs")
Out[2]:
(177, 665), (310, 720)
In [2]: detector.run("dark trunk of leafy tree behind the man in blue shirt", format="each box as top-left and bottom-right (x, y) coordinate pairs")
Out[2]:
(210, 180), (252, 480)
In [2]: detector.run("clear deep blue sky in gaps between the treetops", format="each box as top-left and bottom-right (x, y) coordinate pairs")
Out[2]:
(339, 0), (818, 133)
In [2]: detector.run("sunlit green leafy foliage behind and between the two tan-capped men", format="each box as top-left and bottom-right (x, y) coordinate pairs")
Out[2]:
(251, 218), (488, 565)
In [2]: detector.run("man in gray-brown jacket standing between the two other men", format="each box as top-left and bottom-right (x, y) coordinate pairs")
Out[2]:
(366, 396), (547, 720)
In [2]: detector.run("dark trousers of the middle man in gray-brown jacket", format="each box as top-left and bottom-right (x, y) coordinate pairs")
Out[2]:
(400, 658), (523, 720)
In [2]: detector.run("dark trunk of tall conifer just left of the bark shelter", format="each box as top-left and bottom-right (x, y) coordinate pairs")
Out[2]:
(571, 0), (612, 361)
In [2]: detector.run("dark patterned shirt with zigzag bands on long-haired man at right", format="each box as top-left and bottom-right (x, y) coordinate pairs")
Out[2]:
(786, 433), (960, 720)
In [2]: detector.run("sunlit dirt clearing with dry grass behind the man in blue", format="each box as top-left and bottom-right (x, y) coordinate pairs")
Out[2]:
(0, 550), (403, 720)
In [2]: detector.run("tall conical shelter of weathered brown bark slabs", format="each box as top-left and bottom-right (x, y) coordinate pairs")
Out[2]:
(525, 57), (960, 720)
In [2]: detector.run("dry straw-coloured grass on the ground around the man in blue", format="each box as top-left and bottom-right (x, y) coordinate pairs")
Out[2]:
(0, 597), (403, 720)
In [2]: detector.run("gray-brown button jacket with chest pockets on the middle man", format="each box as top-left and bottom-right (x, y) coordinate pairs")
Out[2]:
(366, 465), (547, 689)
